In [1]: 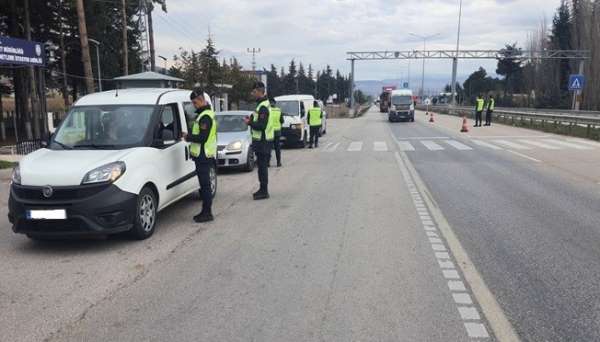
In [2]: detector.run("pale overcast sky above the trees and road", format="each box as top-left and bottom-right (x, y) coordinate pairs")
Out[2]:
(154, 0), (560, 88)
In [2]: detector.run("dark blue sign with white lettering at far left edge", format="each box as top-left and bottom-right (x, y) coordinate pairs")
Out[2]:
(0, 36), (46, 66)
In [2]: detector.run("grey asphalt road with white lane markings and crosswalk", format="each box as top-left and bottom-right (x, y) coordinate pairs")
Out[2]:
(0, 110), (600, 341)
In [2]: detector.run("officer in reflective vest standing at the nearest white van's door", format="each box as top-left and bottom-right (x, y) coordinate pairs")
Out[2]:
(186, 88), (217, 223)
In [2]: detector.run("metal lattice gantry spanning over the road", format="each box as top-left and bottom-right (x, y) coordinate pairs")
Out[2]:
(346, 49), (590, 107)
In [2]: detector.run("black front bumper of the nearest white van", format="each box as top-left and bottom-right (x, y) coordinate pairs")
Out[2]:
(8, 184), (137, 237)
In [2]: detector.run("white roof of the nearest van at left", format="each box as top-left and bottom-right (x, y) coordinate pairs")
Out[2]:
(75, 88), (191, 106)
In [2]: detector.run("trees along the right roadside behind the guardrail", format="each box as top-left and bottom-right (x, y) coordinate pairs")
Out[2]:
(446, 0), (600, 110)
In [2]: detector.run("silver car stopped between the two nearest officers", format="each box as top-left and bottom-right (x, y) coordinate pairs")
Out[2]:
(216, 111), (255, 171)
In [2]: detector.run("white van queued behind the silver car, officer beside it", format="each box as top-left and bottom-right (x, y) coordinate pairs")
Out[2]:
(275, 95), (324, 147)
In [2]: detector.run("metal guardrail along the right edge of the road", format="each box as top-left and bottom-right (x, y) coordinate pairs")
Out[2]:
(417, 106), (600, 140)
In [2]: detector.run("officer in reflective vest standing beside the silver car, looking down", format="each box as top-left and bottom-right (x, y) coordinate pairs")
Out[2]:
(245, 81), (275, 200)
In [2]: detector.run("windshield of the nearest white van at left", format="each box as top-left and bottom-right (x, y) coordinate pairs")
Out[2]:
(50, 105), (154, 149)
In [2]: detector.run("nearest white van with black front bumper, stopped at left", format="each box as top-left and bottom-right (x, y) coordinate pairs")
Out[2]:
(8, 89), (217, 239)
